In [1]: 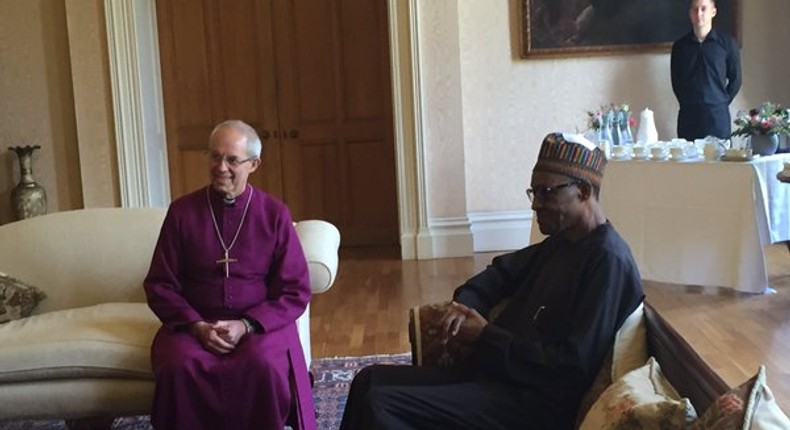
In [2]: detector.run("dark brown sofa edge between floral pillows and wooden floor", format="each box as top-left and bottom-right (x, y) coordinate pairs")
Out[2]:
(645, 304), (730, 411)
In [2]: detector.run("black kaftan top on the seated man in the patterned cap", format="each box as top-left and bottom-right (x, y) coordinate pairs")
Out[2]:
(454, 222), (644, 413)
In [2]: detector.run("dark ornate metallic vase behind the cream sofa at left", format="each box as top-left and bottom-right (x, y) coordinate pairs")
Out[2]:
(8, 145), (47, 220)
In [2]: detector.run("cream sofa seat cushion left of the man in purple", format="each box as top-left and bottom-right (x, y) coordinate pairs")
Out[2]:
(0, 303), (161, 383)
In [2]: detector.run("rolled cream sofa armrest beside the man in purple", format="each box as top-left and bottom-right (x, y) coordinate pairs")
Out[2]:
(294, 220), (340, 294)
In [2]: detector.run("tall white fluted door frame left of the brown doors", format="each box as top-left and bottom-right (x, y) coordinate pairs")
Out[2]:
(104, 0), (170, 207)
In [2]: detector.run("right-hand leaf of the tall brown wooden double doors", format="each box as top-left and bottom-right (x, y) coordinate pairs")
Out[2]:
(274, 0), (398, 246)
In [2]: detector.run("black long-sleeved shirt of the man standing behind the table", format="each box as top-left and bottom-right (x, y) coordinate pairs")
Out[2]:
(671, 29), (742, 108)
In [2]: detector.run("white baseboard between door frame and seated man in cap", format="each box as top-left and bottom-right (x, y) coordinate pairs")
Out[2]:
(469, 210), (533, 252)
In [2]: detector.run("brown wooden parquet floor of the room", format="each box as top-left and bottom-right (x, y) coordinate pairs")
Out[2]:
(310, 245), (790, 413)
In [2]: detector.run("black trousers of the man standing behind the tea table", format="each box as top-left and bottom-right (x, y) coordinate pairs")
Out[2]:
(677, 104), (732, 141)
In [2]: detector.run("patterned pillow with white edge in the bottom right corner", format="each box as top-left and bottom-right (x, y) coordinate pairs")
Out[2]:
(691, 366), (790, 430)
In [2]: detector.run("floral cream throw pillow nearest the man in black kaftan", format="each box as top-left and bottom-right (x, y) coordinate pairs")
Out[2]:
(579, 357), (697, 430)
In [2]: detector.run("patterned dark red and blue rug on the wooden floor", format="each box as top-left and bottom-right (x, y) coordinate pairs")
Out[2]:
(0, 353), (411, 430)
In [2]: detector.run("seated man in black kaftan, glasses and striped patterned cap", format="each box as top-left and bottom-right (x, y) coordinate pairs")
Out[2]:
(341, 134), (644, 430)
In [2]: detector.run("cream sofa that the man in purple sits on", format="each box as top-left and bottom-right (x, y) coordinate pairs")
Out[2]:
(0, 208), (340, 421)
